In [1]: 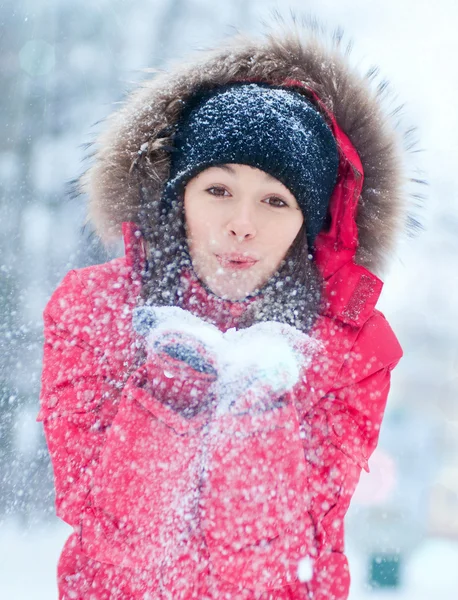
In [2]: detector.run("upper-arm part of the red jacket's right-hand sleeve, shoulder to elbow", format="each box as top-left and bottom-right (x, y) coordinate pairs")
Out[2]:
(301, 312), (402, 568)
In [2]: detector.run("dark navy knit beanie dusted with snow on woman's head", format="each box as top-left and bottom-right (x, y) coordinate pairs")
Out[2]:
(162, 83), (339, 248)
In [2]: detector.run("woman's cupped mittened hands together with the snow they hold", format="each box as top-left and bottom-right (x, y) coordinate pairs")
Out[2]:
(134, 307), (317, 415)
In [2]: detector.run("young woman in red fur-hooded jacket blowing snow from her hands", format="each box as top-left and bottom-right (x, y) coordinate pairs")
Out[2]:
(39, 23), (403, 600)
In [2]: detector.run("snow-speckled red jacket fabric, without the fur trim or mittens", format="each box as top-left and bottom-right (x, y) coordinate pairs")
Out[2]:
(39, 91), (402, 600)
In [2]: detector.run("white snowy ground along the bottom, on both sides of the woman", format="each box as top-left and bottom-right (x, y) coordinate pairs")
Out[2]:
(0, 522), (458, 600)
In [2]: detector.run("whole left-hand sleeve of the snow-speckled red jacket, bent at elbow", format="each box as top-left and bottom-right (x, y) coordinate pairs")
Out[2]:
(38, 272), (211, 568)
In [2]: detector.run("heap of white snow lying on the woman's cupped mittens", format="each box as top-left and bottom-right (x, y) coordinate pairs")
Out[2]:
(133, 306), (318, 414)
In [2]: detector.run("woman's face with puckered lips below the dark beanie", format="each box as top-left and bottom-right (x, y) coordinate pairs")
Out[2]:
(184, 164), (304, 300)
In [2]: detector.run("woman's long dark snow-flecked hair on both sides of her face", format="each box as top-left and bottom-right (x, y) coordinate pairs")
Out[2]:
(139, 187), (322, 332)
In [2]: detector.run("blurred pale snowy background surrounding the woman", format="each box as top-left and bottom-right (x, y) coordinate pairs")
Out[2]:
(0, 0), (458, 600)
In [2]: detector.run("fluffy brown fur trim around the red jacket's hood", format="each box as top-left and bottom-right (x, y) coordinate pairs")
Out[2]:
(80, 19), (416, 273)
